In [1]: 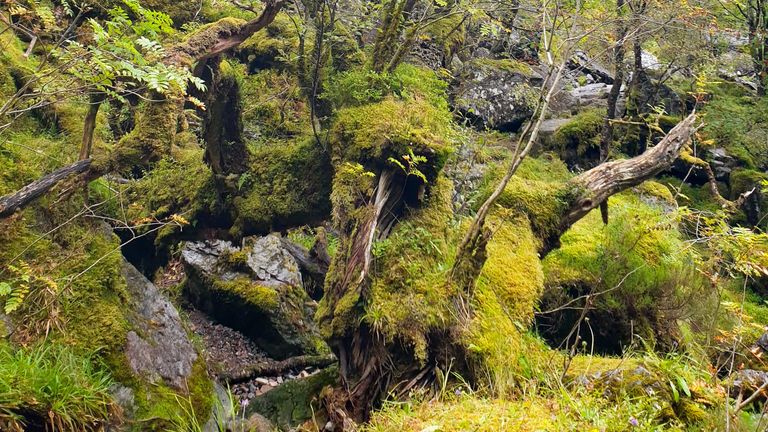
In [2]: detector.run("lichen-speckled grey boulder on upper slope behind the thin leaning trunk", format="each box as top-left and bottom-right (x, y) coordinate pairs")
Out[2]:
(453, 60), (542, 132)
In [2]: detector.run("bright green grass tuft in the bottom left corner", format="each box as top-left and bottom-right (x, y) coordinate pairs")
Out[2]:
(0, 342), (118, 431)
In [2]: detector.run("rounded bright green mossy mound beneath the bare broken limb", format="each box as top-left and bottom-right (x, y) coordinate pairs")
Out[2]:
(539, 192), (709, 354)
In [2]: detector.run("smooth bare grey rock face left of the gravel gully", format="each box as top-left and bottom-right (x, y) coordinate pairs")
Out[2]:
(123, 262), (197, 390)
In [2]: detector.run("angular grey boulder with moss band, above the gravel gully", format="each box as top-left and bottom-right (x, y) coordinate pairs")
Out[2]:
(182, 234), (325, 359)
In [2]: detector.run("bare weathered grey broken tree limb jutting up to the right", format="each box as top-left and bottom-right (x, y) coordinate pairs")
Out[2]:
(541, 113), (698, 256)
